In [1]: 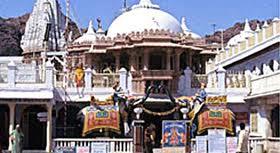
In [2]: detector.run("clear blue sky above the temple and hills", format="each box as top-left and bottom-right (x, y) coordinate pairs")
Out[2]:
(0, 0), (280, 36)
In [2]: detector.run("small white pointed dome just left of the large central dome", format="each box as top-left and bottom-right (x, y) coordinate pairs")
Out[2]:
(74, 21), (96, 44)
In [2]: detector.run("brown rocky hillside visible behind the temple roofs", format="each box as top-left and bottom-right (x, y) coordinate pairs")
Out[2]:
(0, 14), (271, 56)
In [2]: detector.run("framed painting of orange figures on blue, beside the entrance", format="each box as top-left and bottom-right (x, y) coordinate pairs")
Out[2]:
(162, 121), (187, 147)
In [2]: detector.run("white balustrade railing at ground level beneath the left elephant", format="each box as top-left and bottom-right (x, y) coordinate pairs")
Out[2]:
(53, 138), (133, 153)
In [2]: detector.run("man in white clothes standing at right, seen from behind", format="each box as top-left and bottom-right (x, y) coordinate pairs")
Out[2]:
(237, 123), (249, 153)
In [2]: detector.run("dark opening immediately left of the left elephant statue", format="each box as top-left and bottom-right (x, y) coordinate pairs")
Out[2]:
(56, 105), (82, 138)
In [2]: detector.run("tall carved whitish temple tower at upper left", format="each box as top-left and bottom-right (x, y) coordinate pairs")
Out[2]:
(21, 0), (65, 57)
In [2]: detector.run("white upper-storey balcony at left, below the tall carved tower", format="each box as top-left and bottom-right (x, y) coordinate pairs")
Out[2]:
(0, 62), (54, 99)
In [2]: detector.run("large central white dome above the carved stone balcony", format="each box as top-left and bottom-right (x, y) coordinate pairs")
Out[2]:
(107, 0), (182, 37)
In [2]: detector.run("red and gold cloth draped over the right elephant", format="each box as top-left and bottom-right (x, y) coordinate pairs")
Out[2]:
(197, 109), (234, 134)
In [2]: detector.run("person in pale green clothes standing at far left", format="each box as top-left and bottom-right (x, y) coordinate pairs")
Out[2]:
(10, 124), (24, 153)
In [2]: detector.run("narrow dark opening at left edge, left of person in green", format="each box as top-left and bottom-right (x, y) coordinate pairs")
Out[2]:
(0, 105), (10, 149)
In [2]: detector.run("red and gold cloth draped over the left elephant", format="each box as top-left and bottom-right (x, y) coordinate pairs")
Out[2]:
(83, 105), (120, 135)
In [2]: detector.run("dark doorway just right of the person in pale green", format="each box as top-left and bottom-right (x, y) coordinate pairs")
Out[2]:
(21, 105), (47, 150)
